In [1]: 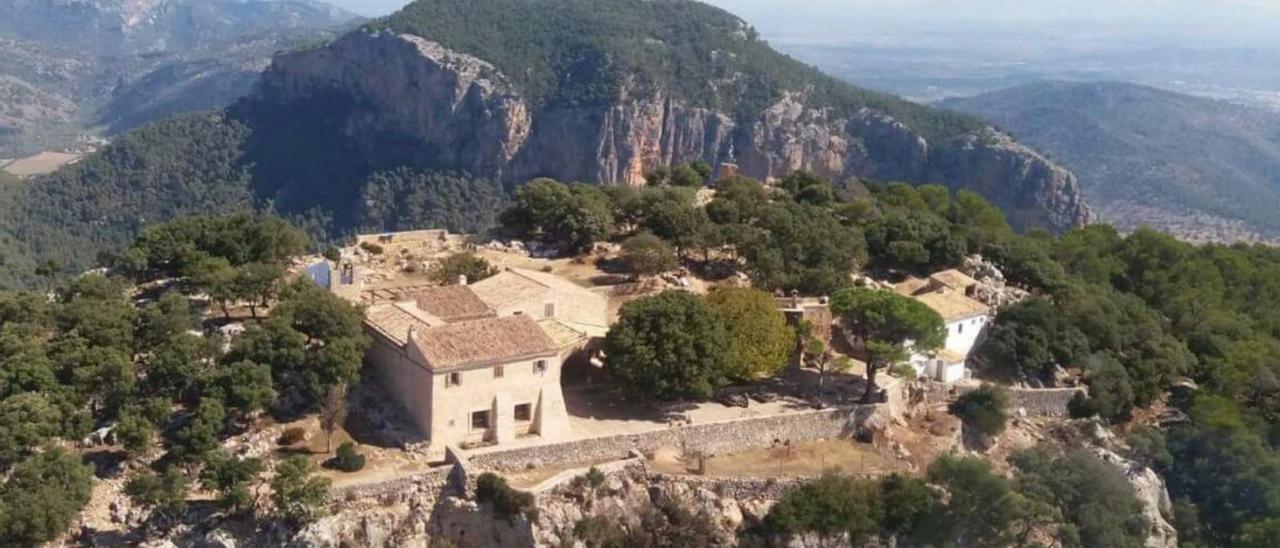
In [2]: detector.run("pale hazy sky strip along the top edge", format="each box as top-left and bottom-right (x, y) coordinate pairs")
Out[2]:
(329, 0), (1280, 41)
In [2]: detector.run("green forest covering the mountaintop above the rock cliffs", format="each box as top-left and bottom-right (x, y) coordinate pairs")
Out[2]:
(369, 0), (982, 138)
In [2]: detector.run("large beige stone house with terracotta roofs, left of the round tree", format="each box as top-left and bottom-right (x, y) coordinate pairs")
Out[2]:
(355, 270), (608, 448)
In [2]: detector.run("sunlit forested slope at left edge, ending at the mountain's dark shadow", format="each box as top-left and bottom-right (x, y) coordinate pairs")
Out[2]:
(0, 114), (253, 287)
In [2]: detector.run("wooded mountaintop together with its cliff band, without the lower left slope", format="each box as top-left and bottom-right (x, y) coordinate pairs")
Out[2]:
(232, 0), (1089, 230)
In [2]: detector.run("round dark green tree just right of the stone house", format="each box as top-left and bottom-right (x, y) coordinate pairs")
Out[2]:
(604, 291), (737, 399)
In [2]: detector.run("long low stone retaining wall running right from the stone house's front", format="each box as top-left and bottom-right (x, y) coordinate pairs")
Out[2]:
(471, 406), (879, 471)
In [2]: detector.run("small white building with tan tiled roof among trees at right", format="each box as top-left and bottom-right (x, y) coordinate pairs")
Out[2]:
(896, 270), (991, 383)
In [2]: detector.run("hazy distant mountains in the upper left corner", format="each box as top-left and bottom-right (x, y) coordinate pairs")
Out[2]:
(0, 0), (360, 157)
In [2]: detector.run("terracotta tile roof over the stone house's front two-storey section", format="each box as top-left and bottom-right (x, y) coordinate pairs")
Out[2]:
(413, 316), (558, 369)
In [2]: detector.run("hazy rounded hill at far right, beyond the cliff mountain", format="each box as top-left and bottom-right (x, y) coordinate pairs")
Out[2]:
(941, 82), (1280, 241)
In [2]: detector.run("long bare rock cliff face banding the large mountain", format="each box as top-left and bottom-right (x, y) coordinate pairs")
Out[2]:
(249, 31), (1089, 230)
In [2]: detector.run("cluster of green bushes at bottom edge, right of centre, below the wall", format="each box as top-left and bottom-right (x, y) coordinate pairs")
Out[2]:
(753, 449), (1147, 547)
